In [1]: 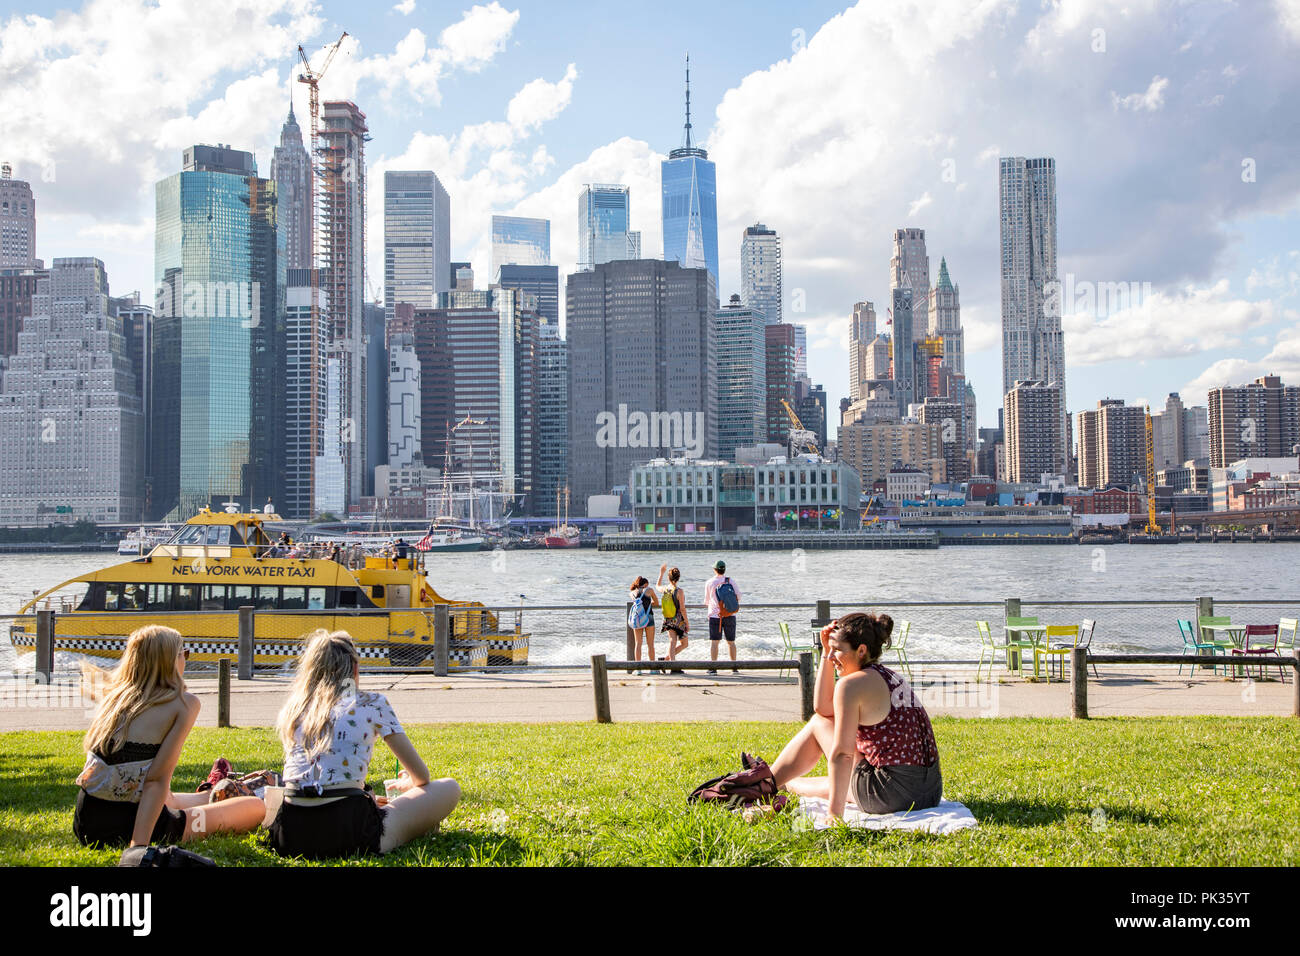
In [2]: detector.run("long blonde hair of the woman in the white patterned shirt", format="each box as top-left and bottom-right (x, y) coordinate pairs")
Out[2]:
(276, 628), (361, 760)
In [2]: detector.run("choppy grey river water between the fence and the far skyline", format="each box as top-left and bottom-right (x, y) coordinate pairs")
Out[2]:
(0, 542), (1300, 674)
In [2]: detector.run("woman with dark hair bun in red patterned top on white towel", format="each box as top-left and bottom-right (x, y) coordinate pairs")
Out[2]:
(772, 613), (944, 818)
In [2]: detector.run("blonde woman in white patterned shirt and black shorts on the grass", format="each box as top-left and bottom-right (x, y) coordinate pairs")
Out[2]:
(268, 631), (460, 858)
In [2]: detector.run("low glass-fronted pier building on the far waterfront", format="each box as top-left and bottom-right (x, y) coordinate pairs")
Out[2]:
(631, 455), (862, 533)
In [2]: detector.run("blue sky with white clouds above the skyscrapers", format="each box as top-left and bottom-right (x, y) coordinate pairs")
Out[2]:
(0, 0), (1300, 434)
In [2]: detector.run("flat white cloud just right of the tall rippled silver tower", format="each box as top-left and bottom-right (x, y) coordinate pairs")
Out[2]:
(1061, 278), (1281, 365)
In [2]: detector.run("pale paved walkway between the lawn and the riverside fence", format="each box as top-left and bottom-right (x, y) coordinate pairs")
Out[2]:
(0, 665), (1295, 731)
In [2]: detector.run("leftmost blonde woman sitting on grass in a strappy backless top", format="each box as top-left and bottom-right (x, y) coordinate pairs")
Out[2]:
(73, 624), (265, 847)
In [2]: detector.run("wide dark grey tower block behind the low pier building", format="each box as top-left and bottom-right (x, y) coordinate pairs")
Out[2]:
(564, 259), (718, 514)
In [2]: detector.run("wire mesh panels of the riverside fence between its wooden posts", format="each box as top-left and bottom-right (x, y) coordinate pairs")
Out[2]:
(0, 598), (1300, 676)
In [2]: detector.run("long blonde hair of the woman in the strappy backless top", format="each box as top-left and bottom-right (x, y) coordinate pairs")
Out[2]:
(83, 624), (185, 754)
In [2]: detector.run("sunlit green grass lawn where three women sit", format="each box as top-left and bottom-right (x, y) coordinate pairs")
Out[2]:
(0, 717), (1300, 866)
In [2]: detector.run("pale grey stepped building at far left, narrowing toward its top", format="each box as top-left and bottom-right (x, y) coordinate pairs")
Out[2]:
(0, 259), (142, 524)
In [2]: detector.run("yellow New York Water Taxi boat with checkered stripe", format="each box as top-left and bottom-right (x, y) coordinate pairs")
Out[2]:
(9, 509), (528, 670)
